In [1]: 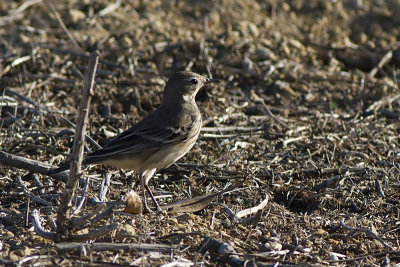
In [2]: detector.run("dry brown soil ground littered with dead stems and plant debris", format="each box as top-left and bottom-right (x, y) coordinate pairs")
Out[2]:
(0, 0), (400, 266)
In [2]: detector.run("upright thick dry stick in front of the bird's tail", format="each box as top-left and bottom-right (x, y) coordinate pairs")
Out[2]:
(57, 51), (99, 239)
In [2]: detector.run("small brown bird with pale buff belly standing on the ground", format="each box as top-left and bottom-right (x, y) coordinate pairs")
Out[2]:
(48, 71), (219, 212)
